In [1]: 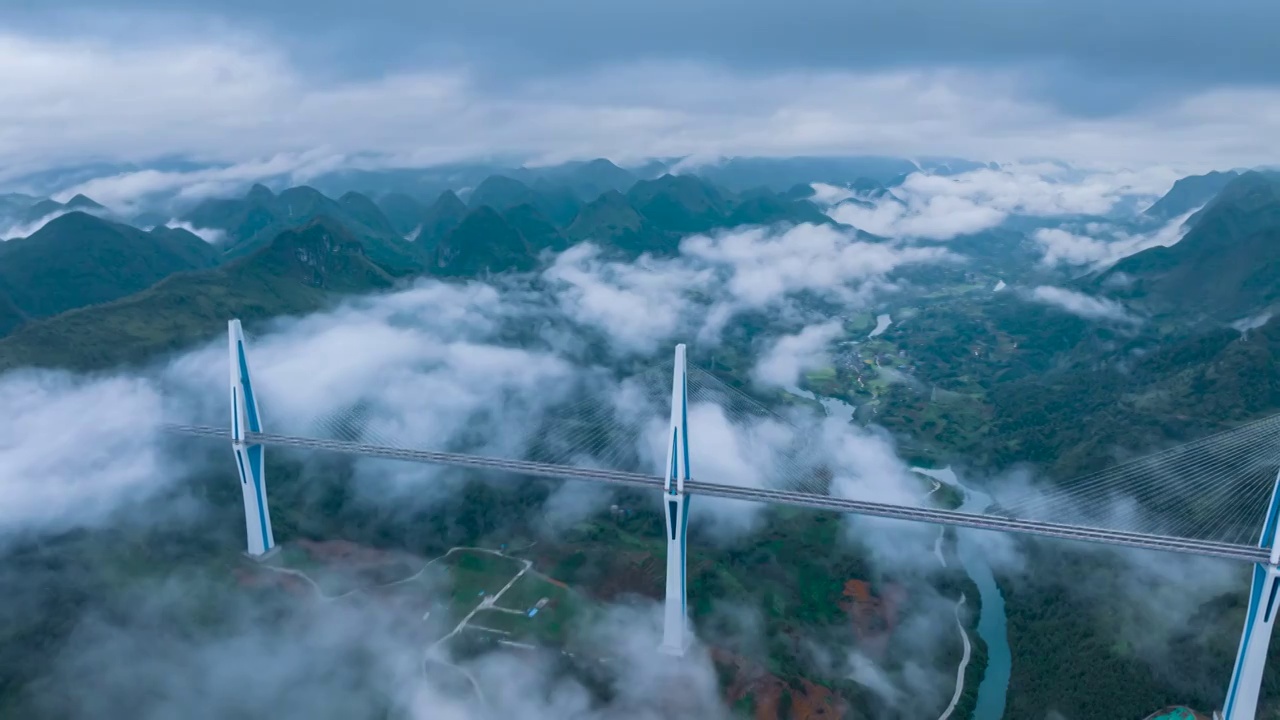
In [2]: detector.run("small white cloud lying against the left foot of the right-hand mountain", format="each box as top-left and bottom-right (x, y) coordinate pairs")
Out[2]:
(1032, 210), (1194, 272)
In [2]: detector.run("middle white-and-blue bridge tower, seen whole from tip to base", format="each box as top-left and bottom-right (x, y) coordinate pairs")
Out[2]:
(660, 345), (692, 656)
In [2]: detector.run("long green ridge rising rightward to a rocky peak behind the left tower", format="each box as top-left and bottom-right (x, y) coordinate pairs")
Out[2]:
(0, 218), (393, 370)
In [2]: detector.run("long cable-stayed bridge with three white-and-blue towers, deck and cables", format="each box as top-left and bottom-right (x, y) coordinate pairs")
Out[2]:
(165, 320), (1280, 720)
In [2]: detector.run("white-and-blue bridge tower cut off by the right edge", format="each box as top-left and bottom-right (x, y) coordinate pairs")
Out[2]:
(1221, 475), (1280, 720)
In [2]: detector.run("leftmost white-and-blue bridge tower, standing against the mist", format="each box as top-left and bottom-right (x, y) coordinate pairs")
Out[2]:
(228, 320), (275, 557)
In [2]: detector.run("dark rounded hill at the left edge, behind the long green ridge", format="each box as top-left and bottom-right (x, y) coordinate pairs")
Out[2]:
(0, 211), (218, 324)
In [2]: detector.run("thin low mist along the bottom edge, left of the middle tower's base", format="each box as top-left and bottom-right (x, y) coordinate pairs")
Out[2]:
(27, 564), (727, 720)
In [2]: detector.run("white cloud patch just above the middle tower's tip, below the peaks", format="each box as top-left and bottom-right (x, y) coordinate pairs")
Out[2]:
(543, 224), (956, 352)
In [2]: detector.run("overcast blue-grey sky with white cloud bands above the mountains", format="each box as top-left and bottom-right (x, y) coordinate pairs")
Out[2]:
(0, 0), (1280, 184)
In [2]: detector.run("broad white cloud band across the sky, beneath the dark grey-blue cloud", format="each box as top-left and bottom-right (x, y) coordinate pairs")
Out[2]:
(0, 24), (1280, 206)
